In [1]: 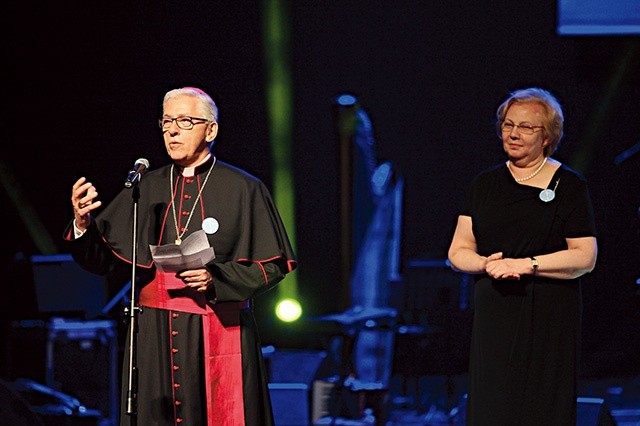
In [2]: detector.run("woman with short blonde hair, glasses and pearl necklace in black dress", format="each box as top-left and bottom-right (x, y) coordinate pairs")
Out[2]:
(448, 88), (597, 426)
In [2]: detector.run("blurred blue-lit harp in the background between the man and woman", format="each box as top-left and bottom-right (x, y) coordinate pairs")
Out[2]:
(312, 94), (404, 420)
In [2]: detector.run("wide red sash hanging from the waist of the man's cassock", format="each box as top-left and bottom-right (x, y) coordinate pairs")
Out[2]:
(139, 272), (248, 426)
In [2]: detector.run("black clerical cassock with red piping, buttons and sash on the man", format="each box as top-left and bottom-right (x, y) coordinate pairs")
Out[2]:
(65, 157), (296, 426)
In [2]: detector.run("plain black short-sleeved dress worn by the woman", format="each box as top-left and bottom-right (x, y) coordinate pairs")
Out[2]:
(462, 164), (595, 426)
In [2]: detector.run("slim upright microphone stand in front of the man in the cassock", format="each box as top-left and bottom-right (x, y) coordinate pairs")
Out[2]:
(126, 185), (141, 426)
